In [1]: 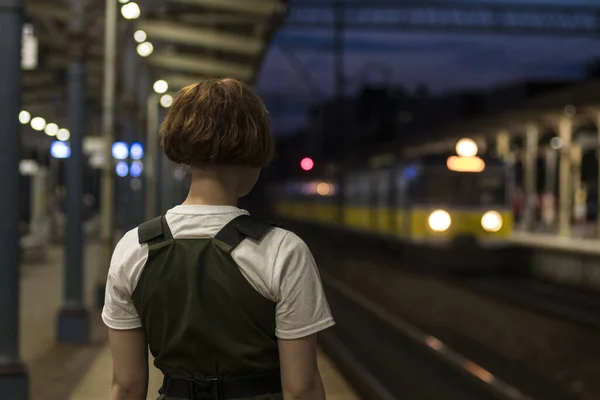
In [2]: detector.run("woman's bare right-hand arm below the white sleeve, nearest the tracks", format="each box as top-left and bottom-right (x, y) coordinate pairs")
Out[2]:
(279, 334), (325, 400)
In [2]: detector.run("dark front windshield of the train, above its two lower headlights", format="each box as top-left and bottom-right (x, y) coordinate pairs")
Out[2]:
(411, 168), (507, 207)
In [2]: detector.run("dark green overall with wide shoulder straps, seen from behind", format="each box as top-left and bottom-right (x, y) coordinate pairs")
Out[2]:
(132, 215), (282, 400)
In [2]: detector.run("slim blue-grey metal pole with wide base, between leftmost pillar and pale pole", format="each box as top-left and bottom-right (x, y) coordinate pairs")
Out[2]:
(58, 0), (90, 343)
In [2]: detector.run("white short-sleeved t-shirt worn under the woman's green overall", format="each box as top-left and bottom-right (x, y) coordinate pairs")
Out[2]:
(102, 205), (335, 339)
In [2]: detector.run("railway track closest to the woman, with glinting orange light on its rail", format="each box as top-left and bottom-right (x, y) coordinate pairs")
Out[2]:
(322, 274), (536, 400)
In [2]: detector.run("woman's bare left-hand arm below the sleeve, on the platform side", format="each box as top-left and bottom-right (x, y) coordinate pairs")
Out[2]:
(108, 329), (148, 400)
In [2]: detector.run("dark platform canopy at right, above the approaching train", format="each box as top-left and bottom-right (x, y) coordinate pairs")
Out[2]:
(376, 78), (600, 155)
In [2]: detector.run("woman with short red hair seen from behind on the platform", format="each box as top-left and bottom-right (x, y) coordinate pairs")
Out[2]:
(102, 79), (334, 400)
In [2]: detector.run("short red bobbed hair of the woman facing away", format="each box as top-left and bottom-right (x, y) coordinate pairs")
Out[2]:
(160, 78), (275, 167)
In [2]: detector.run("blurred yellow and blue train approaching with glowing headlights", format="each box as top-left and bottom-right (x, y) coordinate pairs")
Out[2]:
(271, 138), (514, 248)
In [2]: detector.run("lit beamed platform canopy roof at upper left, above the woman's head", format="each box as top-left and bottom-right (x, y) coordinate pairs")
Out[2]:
(22, 0), (287, 130)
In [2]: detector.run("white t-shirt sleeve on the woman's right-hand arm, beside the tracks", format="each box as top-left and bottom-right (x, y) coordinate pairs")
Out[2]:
(273, 232), (335, 339)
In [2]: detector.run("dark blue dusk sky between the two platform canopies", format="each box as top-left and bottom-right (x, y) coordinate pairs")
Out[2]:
(258, 0), (600, 133)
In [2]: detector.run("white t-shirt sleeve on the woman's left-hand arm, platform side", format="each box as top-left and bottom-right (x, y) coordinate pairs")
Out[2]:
(102, 229), (148, 330)
